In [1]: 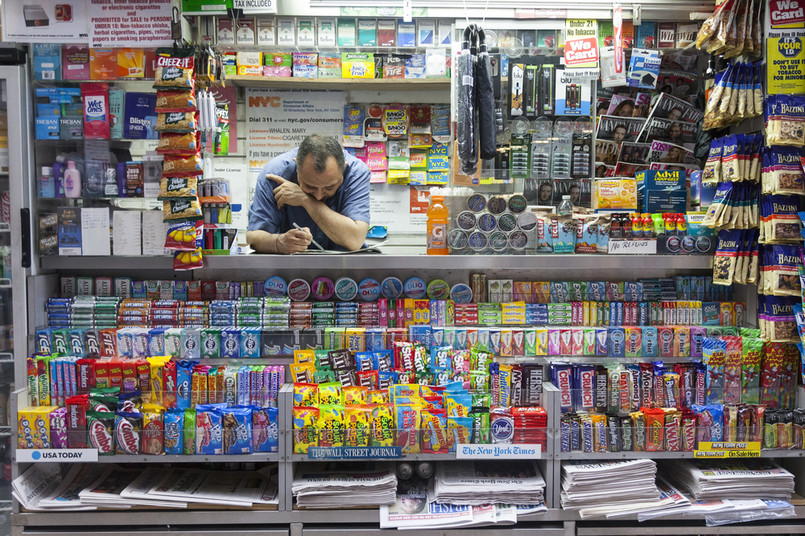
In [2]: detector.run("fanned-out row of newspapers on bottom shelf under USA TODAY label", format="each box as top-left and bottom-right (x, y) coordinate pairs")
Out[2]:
(11, 463), (277, 512)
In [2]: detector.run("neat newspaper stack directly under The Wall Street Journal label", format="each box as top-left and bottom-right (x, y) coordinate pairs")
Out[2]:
(291, 463), (397, 508)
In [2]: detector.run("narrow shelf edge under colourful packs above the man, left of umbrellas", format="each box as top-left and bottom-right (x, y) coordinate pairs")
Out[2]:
(226, 75), (450, 90)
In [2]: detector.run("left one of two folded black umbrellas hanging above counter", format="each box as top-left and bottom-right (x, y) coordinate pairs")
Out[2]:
(456, 24), (478, 175)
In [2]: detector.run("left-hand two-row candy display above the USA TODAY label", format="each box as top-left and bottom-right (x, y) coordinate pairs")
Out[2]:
(17, 355), (284, 455)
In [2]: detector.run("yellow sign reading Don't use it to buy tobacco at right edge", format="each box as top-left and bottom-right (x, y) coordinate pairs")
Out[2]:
(766, 34), (805, 95)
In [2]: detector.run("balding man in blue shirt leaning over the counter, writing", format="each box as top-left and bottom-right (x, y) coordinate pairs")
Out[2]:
(246, 134), (370, 254)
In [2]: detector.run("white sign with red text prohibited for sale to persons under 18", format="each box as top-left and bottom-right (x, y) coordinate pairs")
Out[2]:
(89, 0), (173, 48)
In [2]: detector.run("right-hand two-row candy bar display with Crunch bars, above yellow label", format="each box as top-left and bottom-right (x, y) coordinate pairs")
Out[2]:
(551, 338), (805, 452)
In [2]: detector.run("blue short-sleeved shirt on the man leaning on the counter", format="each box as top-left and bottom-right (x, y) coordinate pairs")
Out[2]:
(249, 149), (370, 251)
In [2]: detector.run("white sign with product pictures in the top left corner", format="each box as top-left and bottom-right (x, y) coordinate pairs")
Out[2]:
(2, 0), (89, 43)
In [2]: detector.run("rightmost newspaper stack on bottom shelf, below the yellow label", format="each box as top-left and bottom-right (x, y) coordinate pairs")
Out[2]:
(665, 460), (794, 500)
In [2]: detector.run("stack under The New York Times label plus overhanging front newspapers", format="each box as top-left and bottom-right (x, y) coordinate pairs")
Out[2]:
(380, 461), (547, 529)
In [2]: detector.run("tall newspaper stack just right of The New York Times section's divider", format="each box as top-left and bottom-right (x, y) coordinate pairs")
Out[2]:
(561, 459), (662, 517)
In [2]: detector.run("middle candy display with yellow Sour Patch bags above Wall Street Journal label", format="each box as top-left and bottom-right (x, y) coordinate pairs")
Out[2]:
(291, 341), (547, 454)
